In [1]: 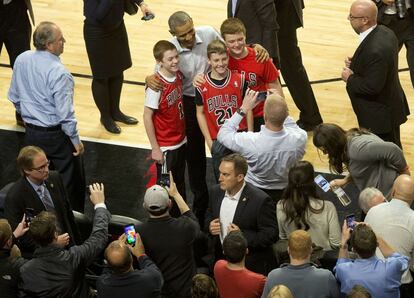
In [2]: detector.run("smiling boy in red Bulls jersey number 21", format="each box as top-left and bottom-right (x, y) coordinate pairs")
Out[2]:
(195, 40), (250, 181)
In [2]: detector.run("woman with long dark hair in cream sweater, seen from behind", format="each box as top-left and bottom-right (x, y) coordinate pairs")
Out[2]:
(277, 161), (341, 250)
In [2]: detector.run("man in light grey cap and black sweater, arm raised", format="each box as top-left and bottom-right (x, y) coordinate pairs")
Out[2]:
(137, 173), (200, 298)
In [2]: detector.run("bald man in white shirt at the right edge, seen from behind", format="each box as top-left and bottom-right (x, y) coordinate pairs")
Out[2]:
(365, 175), (414, 298)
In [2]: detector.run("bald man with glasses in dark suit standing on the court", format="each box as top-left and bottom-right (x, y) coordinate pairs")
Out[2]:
(342, 0), (410, 147)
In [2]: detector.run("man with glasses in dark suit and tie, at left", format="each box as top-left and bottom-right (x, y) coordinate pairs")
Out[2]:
(4, 146), (80, 257)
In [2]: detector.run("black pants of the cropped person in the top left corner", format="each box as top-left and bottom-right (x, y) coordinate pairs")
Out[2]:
(0, 0), (32, 67)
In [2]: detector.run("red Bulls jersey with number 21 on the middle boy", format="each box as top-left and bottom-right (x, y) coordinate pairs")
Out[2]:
(197, 71), (247, 140)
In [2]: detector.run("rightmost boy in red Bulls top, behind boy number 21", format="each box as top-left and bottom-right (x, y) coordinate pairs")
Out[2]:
(220, 18), (284, 131)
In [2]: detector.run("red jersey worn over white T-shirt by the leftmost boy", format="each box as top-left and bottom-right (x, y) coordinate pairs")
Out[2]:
(152, 72), (185, 147)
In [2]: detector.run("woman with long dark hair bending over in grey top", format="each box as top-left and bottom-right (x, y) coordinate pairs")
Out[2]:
(313, 123), (410, 197)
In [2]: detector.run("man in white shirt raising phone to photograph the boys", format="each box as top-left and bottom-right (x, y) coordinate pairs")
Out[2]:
(217, 90), (307, 201)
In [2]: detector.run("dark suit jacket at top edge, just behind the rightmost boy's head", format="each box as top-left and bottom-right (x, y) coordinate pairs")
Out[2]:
(227, 0), (279, 57)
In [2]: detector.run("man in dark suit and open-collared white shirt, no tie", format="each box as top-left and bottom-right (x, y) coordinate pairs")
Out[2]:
(205, 153), (278, 275)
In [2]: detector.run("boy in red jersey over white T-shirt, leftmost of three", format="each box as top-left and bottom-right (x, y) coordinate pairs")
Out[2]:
(144, 40), (187, 216)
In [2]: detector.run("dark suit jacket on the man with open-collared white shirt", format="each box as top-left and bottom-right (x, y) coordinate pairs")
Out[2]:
(205, 182), (279, 275)
